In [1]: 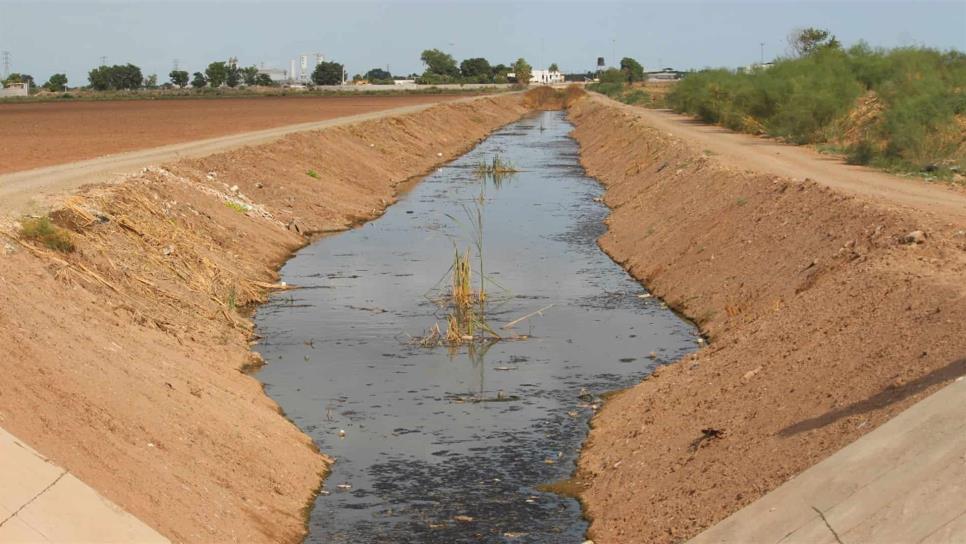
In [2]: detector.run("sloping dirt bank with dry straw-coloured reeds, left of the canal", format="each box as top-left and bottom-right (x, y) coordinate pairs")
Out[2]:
(0, 95), (525, 542)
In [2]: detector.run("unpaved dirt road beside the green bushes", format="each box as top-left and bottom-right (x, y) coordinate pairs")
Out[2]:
(600, 97), (966, 220)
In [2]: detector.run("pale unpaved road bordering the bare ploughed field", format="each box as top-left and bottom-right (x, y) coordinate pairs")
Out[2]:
(0, 97), (468, 220)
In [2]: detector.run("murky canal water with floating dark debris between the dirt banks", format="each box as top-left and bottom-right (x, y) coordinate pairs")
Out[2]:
(256, 112), (696, 543)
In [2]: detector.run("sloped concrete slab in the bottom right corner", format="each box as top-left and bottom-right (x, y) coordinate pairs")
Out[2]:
(691, 378), (966, 544)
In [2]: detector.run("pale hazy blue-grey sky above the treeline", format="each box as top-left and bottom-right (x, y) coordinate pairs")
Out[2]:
(0, 0), (966, 85)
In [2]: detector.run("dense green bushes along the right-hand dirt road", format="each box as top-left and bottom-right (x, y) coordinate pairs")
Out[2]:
(667, 29), (966, 182)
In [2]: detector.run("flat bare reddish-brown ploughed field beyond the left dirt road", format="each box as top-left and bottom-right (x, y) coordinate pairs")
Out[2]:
(0, 95), (465, 174)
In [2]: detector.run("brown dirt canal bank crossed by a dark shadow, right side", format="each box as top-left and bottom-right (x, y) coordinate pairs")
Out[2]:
(571, 95), (966, 543)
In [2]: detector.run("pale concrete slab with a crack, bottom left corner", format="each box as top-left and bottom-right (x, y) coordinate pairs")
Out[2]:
(0, 429), (169, 544)
